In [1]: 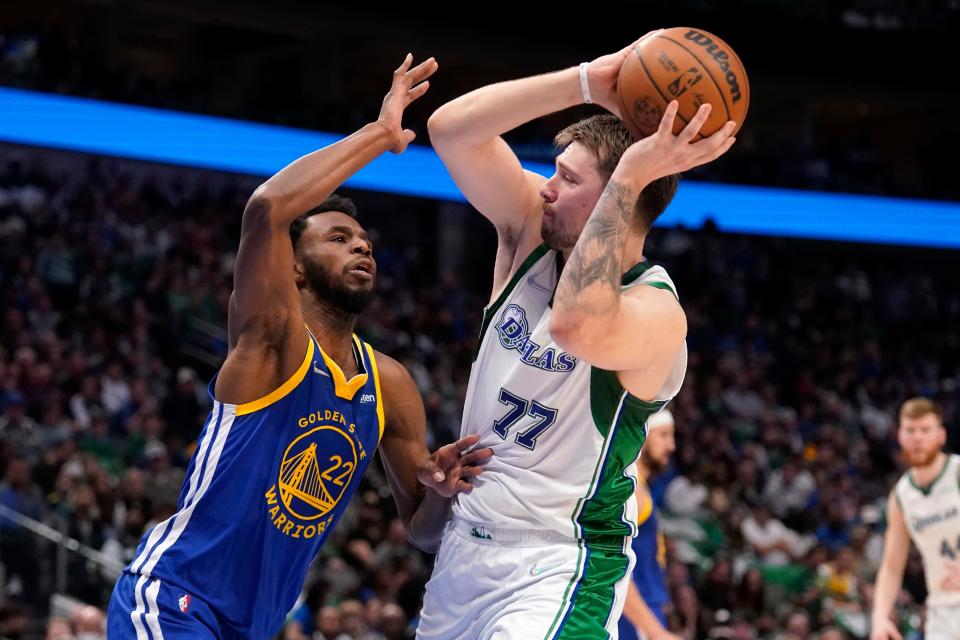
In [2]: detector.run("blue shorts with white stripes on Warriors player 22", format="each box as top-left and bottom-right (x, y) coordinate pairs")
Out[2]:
(107, 572), (229, 640)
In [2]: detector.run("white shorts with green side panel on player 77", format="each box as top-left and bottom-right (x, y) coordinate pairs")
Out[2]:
(417, 520), (634, 640)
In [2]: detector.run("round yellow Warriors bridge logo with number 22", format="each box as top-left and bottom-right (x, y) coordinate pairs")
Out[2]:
(265, 420), (365, 539)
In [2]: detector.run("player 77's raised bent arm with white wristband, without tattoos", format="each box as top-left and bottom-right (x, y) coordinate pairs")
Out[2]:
(428, 44), (648, 295)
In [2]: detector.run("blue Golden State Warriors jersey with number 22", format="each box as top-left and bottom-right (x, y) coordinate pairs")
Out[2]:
(127, 336), (384, 638)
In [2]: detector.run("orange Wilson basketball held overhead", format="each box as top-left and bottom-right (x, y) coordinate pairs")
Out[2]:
(617, 27), (750, 139)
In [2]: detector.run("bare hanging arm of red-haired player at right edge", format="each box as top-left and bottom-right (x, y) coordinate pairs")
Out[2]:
(870, 491), (910, 640)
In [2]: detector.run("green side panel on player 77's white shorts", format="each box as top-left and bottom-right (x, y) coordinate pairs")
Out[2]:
(546, 544), (630, 640)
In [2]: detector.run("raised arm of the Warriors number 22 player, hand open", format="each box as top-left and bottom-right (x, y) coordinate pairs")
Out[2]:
(216, 55), (437, 403)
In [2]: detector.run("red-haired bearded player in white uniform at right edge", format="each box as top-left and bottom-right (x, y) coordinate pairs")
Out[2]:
(870, 398), (960, 640)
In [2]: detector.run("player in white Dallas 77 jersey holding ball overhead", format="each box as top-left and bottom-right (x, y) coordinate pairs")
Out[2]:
(418, 35), (733, 640)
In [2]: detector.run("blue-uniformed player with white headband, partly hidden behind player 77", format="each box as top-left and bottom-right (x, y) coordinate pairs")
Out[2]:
(620, 409), (680, 640)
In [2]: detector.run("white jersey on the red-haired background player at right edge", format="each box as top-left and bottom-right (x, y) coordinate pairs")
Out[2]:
(893, 455), (960, 607)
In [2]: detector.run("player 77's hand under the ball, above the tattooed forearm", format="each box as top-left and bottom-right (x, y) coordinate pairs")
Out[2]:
(615, 100), (736, 186)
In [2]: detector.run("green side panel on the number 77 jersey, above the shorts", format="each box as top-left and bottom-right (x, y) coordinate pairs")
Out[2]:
(574, 367), (667, 541)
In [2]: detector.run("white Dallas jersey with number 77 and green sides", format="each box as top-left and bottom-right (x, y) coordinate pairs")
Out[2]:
(453, 245), (687, 540)
